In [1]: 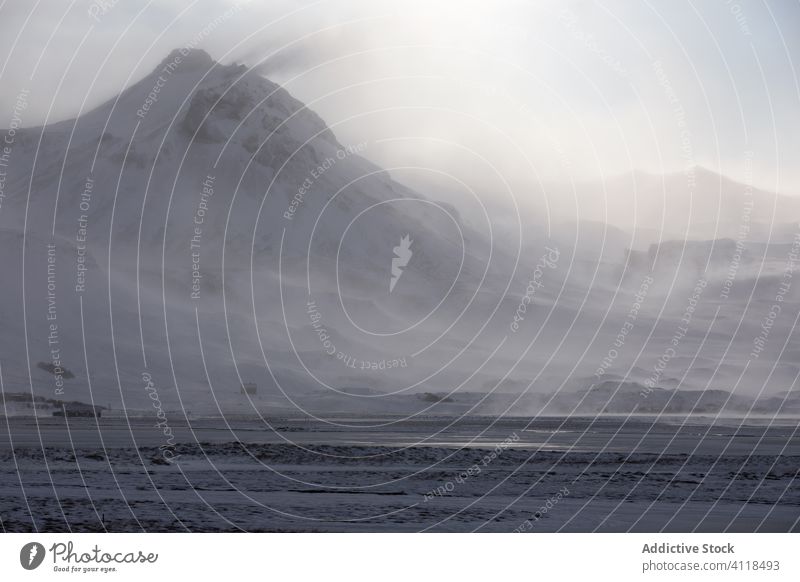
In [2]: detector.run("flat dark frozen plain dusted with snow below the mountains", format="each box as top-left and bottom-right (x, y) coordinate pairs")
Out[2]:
(0, 417), (800, 531)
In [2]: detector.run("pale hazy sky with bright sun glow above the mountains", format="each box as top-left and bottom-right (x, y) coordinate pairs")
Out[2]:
(0, 0), (800, 194)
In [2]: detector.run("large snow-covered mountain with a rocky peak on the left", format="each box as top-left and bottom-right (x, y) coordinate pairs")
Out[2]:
(0, 50), (508, 416)
